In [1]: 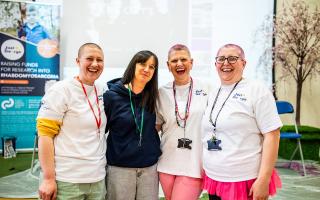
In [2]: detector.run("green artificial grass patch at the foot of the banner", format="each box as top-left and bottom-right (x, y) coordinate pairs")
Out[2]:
(0, 153), (32, 177)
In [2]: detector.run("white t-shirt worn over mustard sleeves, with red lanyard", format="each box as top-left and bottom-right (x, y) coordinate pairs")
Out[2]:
(38, 79), (106, 183)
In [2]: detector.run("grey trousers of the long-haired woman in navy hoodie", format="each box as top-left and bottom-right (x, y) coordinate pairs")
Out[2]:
(107, 164), (159, 200)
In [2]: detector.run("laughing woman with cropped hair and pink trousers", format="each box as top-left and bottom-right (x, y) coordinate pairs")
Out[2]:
(157, 44), (208, 200)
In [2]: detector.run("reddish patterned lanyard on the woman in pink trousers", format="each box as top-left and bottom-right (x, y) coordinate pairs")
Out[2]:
(172, 77), (193, 137)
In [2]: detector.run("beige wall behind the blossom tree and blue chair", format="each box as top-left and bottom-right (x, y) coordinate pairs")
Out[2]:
(275, 0), (320, 127)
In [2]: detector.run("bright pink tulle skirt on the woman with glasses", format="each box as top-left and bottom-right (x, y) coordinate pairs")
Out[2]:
(203, 169), (282, 200)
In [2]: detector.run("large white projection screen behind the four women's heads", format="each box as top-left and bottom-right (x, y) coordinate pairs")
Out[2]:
(61, 0), (273, 87)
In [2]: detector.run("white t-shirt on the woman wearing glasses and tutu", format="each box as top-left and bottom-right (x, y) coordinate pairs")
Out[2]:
(202, 79), (282, 182)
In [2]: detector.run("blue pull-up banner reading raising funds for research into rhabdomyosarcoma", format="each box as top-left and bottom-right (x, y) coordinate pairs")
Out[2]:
(0, 1), (60, 148)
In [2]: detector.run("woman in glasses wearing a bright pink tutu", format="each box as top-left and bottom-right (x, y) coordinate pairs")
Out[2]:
(202, 44), (282, 200)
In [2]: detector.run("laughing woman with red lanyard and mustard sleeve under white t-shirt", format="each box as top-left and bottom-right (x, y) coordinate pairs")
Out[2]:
(37, 43), (107, 200)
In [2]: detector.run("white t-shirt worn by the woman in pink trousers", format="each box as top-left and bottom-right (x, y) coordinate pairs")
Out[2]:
(157, 80), (208, 178)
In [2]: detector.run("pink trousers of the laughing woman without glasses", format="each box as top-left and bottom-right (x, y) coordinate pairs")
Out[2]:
(159, 172), (202, 200)
